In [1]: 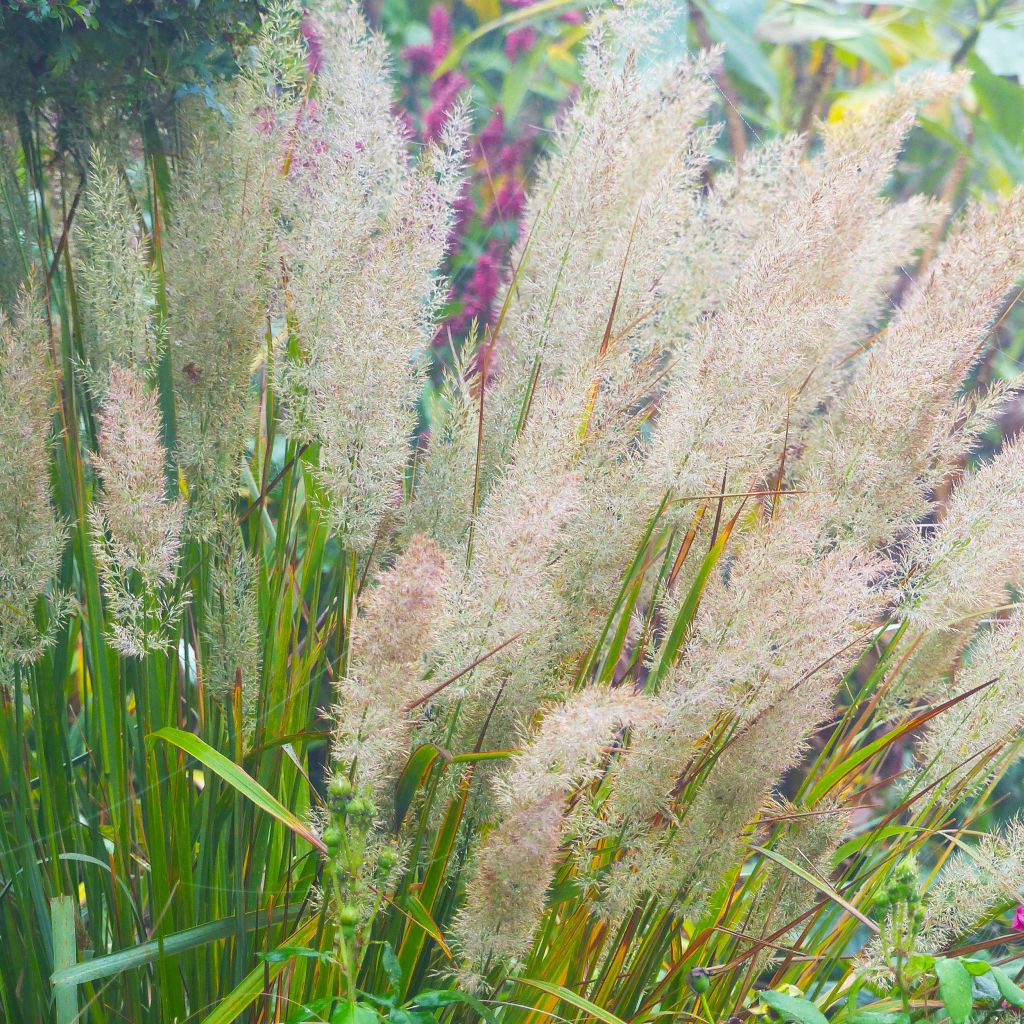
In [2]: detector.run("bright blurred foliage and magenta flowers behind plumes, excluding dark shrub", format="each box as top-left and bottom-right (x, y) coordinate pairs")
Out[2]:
(368, 0), (1024, 399)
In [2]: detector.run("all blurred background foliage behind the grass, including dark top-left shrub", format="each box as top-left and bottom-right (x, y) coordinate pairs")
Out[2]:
(0, 0), (1024, 348)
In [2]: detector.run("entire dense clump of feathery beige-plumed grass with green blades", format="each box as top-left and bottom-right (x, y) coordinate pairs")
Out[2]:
(0, 3), (1024, 1024)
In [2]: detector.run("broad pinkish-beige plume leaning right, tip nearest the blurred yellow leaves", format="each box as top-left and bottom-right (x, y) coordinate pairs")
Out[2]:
(649, 76), (959, 507)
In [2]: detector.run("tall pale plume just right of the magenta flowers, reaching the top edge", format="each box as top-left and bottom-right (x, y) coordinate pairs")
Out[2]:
(407, 12), (718, 536)
